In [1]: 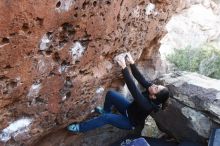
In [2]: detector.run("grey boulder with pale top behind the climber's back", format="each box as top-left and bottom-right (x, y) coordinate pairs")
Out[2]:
(154, 72), (220, 143)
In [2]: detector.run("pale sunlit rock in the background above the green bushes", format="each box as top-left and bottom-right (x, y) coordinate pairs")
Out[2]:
(160, 0), (220, 57)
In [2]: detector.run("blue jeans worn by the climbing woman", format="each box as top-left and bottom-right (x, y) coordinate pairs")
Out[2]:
(79, 90), (133, 132)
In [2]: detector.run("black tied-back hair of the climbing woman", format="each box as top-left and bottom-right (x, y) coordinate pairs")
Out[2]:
(153, 87), (170, 110)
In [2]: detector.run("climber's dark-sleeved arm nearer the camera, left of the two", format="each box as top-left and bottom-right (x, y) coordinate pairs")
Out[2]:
(122, 67), (154, 112)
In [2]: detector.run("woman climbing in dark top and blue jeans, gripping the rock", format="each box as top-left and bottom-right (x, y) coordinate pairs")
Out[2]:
(67, 53), (169, 133)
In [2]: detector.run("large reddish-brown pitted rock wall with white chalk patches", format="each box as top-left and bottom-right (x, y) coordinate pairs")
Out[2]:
(0, 0), (178, 145)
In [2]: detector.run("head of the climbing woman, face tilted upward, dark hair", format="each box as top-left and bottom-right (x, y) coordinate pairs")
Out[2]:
(148, 84), (170, 109)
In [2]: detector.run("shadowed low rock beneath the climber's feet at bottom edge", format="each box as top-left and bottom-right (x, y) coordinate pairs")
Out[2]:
(35, 125), (143, 146)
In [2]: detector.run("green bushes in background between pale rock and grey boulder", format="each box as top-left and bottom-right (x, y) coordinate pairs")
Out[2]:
(166, 45), (220, 79)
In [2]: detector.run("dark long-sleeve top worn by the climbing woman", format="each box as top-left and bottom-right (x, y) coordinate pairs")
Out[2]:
(122, 64), (158, 126)
